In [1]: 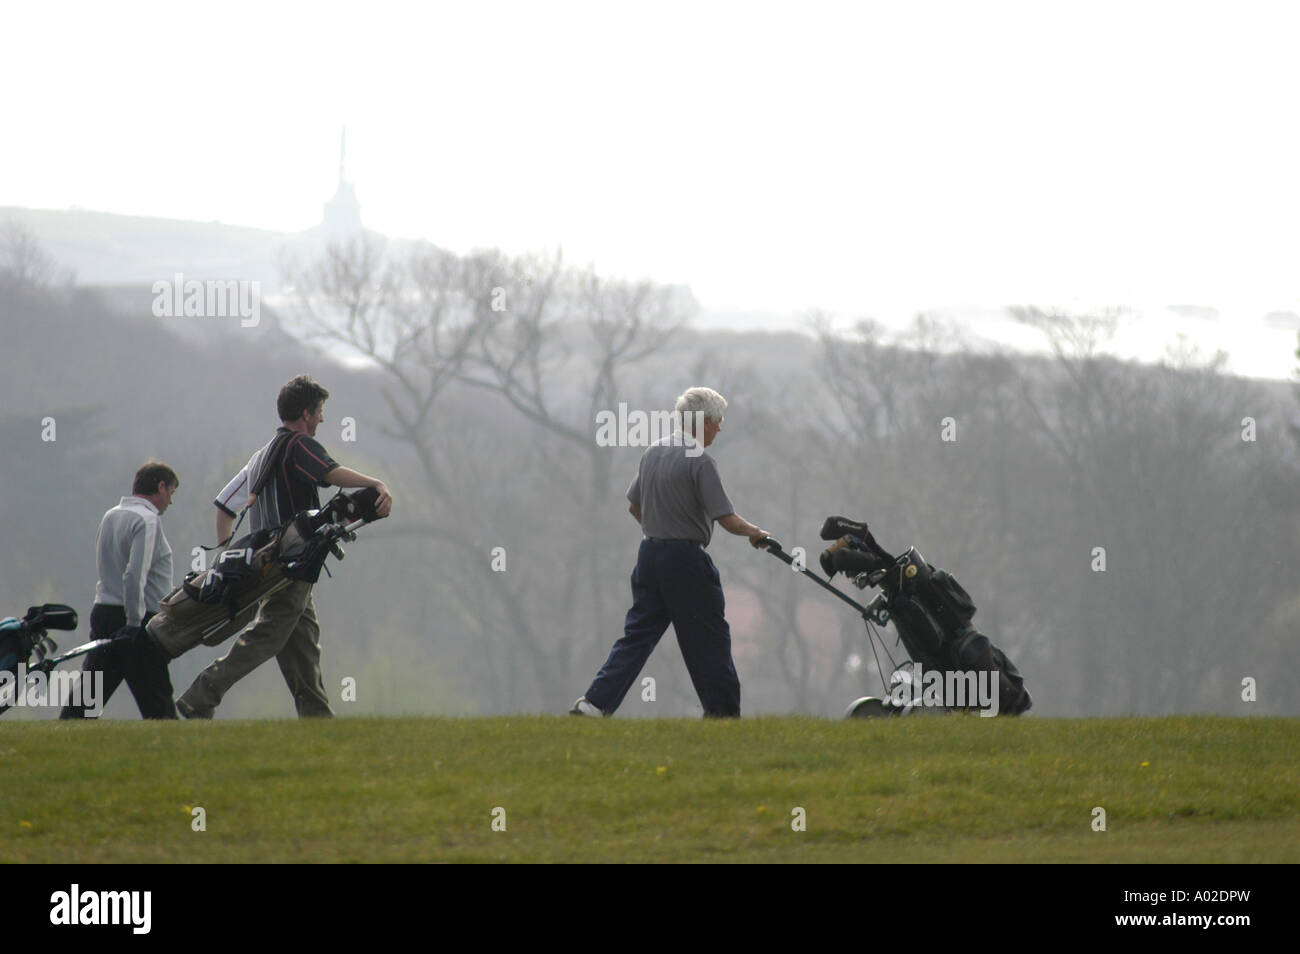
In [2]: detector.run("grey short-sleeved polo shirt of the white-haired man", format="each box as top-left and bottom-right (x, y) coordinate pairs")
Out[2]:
(628, 433), (736, 546)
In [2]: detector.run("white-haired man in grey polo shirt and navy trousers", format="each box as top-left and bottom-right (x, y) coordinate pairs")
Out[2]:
(569, 387), (767, 717)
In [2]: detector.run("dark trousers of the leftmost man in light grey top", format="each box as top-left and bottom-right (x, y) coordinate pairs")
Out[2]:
(59, 603), (177, 719)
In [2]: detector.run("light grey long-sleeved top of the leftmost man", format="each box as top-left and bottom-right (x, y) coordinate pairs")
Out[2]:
(95, 496), (172, 626)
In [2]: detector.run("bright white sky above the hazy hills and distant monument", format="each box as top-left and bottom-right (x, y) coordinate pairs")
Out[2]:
(0, 0), (1300, 374)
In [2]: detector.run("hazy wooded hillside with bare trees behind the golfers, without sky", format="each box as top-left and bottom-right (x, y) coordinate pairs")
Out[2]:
(0, 214), (1300, 716)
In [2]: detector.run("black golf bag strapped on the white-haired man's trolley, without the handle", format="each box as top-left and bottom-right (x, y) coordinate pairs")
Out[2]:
(822, 517), (1032, 715)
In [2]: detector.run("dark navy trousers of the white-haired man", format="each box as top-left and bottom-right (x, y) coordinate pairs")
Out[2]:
(586, 539), (740, 716)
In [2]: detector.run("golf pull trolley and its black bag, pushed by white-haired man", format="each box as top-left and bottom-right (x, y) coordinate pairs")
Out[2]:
(759, 517), (1032, 719)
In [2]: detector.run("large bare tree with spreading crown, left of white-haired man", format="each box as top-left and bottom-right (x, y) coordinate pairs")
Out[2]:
(279, 238), (693, 704)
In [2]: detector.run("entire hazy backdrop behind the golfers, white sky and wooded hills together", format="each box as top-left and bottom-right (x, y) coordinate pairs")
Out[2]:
(0, 3), (1300, 717)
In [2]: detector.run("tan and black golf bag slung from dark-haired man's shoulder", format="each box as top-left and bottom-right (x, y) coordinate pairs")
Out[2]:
(146, 487), (380, 659)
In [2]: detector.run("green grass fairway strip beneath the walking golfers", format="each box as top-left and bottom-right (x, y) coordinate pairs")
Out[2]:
(0, 716), (1300, 863)
